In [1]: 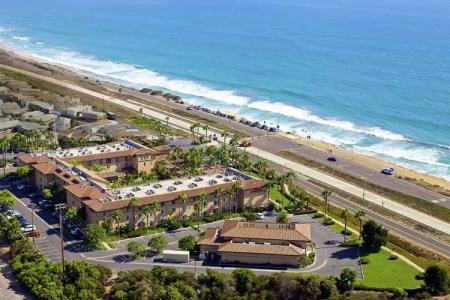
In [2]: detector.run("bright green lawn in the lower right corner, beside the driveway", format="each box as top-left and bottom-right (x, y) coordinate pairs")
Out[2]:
(358, 248), (423, 288)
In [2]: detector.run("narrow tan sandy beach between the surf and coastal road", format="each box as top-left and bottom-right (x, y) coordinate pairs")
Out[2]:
(0, 45), (450, 194)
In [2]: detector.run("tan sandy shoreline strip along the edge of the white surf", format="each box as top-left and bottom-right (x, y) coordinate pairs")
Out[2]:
(0, 44), (450, 193)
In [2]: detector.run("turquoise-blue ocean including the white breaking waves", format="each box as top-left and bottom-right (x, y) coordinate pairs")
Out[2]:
(0, 0), (450, 180)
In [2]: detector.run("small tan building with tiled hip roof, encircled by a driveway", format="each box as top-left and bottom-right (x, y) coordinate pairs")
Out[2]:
(198, 220), (314, 266)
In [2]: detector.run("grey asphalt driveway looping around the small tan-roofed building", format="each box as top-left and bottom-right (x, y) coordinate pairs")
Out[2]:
(84, 215), (361, 276)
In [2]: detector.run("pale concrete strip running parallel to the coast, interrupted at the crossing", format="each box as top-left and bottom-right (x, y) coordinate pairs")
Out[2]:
(0, 65), (450, 234)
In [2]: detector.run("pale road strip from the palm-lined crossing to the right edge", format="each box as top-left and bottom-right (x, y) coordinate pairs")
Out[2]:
(247, 147), (450, 234)
